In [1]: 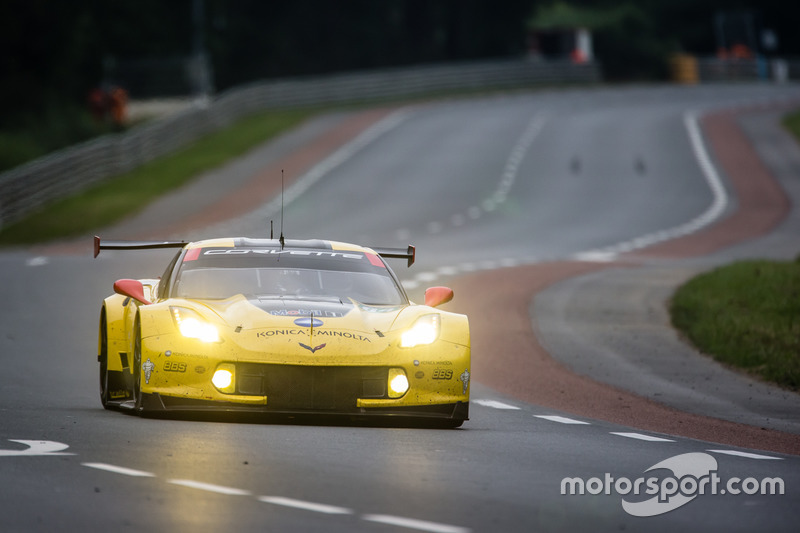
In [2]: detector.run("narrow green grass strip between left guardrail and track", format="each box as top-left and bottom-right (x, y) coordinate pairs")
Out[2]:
(0, 110), (314, 245)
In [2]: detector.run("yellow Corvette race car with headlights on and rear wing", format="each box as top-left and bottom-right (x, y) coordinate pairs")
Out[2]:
(94, 237), (470, 427)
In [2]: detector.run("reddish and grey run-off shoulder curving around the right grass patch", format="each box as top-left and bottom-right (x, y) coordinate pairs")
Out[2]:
(450, 101), (800, 454)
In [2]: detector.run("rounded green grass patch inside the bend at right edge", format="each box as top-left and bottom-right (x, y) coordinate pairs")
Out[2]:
(670, 259), (800, 390)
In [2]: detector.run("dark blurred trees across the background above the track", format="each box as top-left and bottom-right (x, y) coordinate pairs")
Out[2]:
(0, 0), (800, 168)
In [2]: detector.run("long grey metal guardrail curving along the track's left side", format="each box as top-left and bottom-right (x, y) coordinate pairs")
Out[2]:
(0, 60), (600, 228)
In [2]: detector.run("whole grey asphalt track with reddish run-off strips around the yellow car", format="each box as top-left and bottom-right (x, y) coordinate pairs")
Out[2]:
(0, 85), (800, 532)
